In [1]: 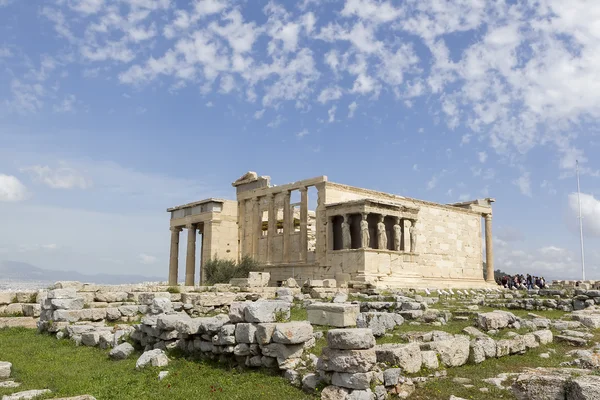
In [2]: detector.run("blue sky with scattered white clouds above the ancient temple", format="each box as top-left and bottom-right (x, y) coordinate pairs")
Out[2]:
(0, 0), (600, 279)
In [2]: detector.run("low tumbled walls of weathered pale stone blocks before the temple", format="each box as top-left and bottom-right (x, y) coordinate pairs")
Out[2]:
(0, 273), (600, 399)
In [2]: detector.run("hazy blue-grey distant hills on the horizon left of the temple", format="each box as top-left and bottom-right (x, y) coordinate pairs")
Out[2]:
(0, 261), (165, 285)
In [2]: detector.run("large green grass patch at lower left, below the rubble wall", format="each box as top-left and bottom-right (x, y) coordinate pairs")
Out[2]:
(0, 329), (314, 400)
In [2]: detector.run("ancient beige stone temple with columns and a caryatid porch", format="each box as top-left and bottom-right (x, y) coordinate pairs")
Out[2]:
(167, 172), (494, 288)
